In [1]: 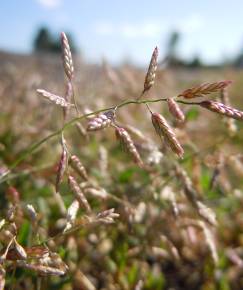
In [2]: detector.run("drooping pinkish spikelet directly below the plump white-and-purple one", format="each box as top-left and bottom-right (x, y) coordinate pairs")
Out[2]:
(115, 127), (143, 167)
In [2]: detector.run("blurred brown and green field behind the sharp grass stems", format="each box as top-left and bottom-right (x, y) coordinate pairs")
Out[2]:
(0, 53), (243, 290)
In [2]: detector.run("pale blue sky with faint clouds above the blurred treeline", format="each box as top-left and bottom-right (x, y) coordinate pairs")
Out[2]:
(0, 0), (243, 65)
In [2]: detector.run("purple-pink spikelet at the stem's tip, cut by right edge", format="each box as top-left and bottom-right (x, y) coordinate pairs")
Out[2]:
(199, 100), (243, 121)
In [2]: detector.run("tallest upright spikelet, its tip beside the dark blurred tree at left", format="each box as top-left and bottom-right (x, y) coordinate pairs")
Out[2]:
(61, 32), (74, 81)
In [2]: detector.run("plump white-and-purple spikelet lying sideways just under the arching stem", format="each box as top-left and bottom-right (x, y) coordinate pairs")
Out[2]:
(87, 110), (114, 131)
